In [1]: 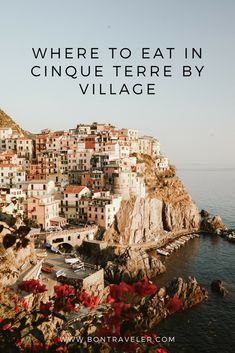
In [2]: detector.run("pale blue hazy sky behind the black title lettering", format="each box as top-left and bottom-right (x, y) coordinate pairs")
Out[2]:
(0, 0), (235, 166)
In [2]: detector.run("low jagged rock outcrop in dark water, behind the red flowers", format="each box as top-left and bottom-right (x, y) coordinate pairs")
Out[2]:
(147, 277), (208, 327)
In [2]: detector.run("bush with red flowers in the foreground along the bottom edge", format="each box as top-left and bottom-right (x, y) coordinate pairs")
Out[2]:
(0, 278), (181, 353)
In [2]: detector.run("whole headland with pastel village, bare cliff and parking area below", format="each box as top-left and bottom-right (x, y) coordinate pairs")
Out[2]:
(0, 111), (228, 295)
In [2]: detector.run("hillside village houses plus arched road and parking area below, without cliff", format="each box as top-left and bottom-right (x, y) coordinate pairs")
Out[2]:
(0, 117), (174, 292)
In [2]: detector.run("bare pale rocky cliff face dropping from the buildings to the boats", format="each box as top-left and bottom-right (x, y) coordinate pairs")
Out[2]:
(104, 157), (200, 245)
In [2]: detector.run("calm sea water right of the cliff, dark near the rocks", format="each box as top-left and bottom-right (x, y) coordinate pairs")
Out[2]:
(156, 166), (235, 353)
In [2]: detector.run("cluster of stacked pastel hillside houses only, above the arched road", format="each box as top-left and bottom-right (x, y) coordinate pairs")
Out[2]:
(0, 123), (169, 231)
